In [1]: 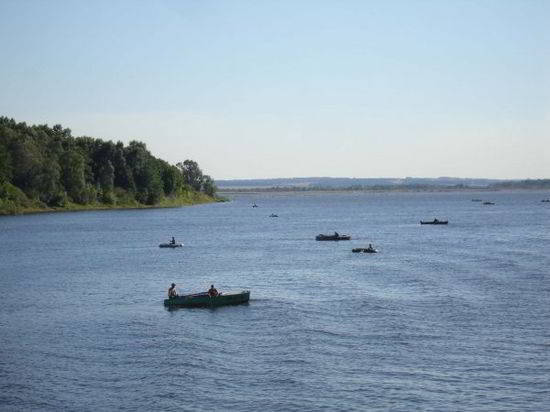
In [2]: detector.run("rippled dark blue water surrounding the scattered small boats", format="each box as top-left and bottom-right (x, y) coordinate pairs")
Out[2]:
(0, 193), (550, 411)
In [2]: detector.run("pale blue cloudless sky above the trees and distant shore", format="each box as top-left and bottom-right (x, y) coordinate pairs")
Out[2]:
(0, 0), (550, 179)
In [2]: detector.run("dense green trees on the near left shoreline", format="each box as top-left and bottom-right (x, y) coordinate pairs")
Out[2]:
(0, 117), (216, 209)
